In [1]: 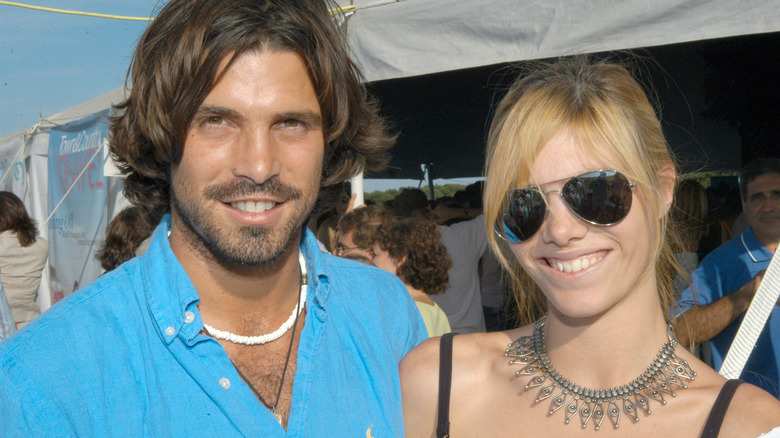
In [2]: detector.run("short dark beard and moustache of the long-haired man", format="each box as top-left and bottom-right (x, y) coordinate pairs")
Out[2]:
(171, 179), (317, 267)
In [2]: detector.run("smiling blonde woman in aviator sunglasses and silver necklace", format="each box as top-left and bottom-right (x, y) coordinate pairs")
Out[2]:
(401, 58), (780, 438)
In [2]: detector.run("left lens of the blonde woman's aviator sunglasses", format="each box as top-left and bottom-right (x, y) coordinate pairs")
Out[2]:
(498, 188), (546, 243)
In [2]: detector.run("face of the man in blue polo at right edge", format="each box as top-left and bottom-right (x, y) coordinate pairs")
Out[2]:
(742, 173), (780, 246)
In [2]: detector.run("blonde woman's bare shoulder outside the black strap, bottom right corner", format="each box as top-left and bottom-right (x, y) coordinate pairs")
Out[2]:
(721, 383), (780, 437)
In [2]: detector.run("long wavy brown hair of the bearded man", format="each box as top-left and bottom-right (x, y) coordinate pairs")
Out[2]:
(110, 0), (394, 222)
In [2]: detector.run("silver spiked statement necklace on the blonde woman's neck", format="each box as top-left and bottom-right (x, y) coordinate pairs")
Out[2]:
(504, 315), (696, 430)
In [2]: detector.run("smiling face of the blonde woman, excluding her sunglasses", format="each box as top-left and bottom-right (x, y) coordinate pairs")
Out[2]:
(510, 130), (657, 318)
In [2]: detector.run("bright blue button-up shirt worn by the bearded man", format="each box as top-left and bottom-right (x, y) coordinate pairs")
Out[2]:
(0, 217), (426, 438)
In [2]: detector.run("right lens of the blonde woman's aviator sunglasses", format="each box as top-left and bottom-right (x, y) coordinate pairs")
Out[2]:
(561, 170), (632, 225)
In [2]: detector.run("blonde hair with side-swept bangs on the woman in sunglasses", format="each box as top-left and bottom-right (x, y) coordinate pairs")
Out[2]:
(484, 56), (678, 324)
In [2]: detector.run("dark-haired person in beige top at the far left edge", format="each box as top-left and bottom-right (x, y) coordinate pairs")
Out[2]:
(0, 192), (49, 328)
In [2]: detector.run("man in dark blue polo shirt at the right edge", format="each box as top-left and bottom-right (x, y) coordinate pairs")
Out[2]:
(675, 158), (780, 397)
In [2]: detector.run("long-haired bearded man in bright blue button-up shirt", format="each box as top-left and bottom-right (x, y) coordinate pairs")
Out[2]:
(0, 0), (425, 437)
